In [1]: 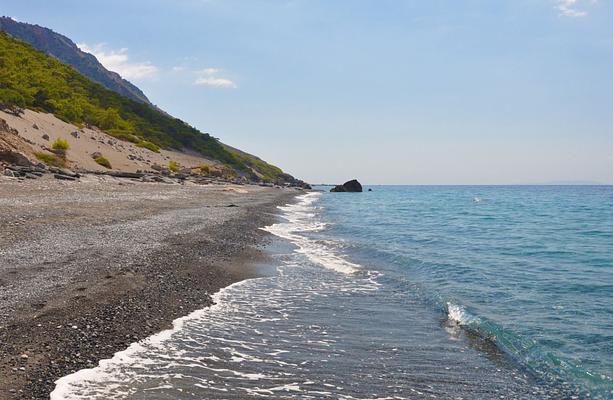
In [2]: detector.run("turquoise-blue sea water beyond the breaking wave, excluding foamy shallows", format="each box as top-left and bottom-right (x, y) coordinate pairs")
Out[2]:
(318, 186), (613, 398)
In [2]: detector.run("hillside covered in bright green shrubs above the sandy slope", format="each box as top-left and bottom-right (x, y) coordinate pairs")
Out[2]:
(0, 32), (293, 182)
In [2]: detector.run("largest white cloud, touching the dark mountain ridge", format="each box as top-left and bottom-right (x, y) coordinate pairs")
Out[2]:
(77, 43), (158, 80)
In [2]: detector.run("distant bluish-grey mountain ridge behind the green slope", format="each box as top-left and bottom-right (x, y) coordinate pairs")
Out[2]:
(0, 17), (151, 104)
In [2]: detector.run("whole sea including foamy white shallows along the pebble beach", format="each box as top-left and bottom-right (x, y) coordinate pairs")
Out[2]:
(51, 186), (613, 400)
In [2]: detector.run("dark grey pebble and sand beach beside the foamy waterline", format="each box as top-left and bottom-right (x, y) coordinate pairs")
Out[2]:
(0, 176), (299, 399)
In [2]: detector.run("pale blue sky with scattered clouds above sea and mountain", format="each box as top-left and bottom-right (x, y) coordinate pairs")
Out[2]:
(0, 0), (613, 184)
